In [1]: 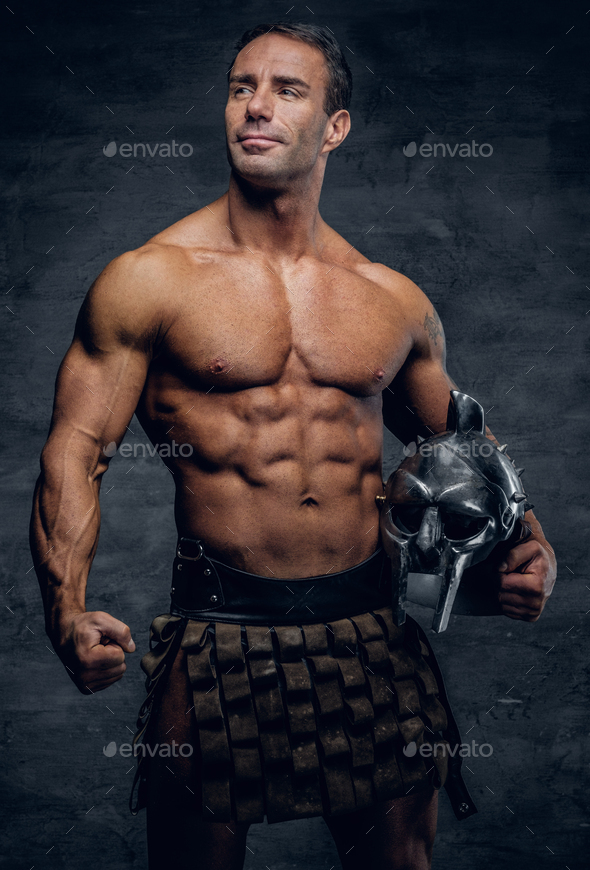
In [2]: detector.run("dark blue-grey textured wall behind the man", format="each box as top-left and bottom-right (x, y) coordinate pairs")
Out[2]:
(0, 0), (590, 870)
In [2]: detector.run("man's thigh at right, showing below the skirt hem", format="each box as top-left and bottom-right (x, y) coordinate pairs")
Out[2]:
(324, 788), (438, 870)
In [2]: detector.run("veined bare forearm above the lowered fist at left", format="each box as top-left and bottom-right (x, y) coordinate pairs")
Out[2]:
(30, 450), (100, 643)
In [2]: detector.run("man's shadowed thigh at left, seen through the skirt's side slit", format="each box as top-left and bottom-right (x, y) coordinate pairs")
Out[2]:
(145, 650), (250, 870)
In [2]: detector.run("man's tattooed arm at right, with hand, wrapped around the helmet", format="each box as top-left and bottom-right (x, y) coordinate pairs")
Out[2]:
(383, 276), (557, 622)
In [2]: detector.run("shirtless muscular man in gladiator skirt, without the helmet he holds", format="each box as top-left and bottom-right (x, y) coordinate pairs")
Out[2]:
(32, 25), (555, 870)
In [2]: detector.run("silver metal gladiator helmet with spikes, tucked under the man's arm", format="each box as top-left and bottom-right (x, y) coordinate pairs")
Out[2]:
(380, 390), (530, 632)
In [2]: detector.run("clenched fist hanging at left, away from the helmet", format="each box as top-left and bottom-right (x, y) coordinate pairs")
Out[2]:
(54, 610), (135, 695)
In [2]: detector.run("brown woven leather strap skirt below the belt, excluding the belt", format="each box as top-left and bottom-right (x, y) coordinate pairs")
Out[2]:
(130, 607), (477, 823)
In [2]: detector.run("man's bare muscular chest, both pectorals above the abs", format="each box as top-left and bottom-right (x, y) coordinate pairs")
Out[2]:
(150, 267), (411, 396)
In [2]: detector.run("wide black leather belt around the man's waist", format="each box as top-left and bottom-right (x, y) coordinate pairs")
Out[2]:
(170, 538), (391, 625)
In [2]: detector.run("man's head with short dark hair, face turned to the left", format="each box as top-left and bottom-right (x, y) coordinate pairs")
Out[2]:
(225, 24), (352, 189)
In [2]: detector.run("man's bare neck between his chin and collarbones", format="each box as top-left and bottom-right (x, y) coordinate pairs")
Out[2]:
(226, 170), (324, 260)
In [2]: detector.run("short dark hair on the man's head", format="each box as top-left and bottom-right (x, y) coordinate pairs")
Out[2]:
(227, 23), (352, 117)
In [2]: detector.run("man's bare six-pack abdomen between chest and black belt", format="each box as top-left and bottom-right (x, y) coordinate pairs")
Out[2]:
(138, 376), (383, 578)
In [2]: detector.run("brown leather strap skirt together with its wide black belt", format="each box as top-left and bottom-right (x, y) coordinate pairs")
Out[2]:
(130, 538), (477, 823)
